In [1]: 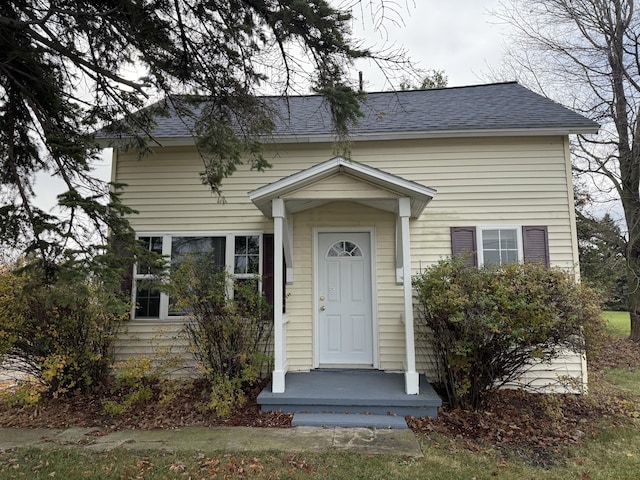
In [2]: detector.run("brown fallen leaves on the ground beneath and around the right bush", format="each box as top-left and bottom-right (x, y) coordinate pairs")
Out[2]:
(408, 339), (640, 464)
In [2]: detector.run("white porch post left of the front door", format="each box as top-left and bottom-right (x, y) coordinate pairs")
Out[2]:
(271, 198), (287, 393)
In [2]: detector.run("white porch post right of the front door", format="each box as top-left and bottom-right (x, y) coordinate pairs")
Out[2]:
(396, 197), (420, 395)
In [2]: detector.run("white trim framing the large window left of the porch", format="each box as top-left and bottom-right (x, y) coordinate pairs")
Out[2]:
(130, 230), (264, 322)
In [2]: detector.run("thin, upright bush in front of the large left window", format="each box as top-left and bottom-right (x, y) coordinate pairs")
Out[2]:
(171, 254), (273, 413)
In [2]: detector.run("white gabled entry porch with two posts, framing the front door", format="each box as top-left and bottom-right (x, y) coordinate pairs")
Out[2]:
(249, 157), (436, 396)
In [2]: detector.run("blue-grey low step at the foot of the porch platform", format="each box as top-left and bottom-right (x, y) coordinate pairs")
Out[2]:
(291, 413), (409, 430)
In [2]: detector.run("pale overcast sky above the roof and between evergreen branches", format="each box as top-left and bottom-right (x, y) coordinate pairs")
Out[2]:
(36, 0), (506, 210)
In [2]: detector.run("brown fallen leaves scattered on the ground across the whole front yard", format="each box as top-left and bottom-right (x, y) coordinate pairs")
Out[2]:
(0, 339), (640, 474)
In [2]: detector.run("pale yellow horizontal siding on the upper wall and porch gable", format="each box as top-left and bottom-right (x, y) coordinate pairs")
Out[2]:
(116, 137), (577, 270)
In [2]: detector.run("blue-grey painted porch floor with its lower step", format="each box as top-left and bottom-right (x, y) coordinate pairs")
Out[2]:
(258, 369), (442, 428)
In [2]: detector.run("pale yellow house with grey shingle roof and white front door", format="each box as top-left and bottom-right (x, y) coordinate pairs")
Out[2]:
(102, 82), (598, 420)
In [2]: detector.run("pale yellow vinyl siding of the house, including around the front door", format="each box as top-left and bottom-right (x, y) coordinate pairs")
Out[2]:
(113, 136), (578, 382)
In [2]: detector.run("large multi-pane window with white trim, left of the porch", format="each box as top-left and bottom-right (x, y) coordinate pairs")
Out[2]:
(133, 232), (262, 319)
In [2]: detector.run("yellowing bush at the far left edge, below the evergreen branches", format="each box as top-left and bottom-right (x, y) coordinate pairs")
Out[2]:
(0, 258), (130, 396)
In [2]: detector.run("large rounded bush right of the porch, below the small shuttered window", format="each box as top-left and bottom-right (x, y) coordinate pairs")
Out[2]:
(414, 258), (603, 408)
